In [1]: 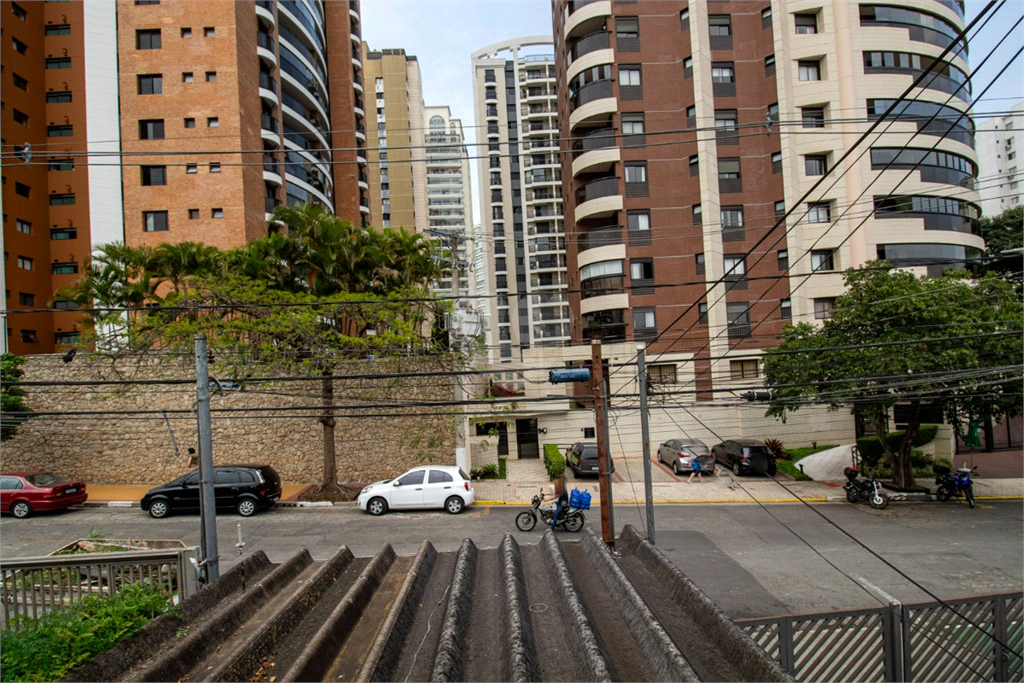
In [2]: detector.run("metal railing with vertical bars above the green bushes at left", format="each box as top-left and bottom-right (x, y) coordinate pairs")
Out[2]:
(0, 548), (197, 629)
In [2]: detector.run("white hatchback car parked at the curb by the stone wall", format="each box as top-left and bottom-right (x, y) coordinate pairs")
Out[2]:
(358, 465), (476, 515)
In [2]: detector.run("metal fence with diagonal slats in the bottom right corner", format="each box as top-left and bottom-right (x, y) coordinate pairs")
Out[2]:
(737, 593), (1024, 681)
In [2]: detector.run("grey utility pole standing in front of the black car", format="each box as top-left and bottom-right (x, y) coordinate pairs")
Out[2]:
(196, 335), (220, 586)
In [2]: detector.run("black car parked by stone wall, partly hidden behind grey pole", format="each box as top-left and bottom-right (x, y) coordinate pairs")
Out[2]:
(141, 465), (281, 519)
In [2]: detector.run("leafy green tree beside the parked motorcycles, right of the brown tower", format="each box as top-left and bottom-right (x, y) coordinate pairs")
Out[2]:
(764, 262), (1022, 486)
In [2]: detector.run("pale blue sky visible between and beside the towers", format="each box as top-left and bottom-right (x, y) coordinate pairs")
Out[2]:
(360, 0), (1024, 223)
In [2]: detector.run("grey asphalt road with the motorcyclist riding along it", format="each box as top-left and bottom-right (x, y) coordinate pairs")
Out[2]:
(0, 501), (1024, 618)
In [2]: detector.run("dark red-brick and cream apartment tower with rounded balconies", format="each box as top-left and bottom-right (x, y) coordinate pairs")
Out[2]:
(553, 0), (983, 398)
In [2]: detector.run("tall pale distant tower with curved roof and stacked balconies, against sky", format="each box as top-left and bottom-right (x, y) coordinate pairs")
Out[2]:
(472, 36), (570, 362)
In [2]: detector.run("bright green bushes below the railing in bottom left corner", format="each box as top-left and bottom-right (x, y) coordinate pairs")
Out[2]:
(0, 584), (169, 681)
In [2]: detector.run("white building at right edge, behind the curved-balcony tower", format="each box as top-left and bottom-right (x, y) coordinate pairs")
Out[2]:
(978, 101), (1024, 216)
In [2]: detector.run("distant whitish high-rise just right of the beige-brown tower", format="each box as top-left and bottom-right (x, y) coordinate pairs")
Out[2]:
(423, 106), (476, 297)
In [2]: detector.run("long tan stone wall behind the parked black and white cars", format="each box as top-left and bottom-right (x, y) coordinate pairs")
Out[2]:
(0, 355), (455, 483)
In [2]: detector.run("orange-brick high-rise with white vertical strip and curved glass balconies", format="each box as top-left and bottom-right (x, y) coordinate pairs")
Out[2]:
(0, 0), (370, 353)
